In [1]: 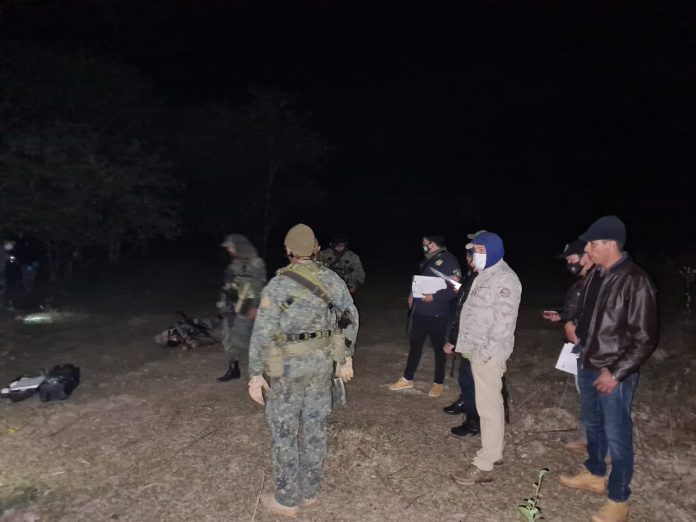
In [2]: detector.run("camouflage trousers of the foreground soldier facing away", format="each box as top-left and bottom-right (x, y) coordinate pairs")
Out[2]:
(266, 373), (331, 506)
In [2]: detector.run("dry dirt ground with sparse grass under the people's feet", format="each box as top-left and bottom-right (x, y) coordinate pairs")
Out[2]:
(0, 264), (696, 522)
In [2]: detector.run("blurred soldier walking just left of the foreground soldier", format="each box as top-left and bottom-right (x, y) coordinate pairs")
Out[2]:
(217, 234), (266, 382)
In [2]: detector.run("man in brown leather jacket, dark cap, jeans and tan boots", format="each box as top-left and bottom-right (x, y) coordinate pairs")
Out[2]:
(560, 216), (657, 522)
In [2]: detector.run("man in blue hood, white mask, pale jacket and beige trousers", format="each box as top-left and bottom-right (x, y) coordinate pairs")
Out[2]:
(453, 232), (522, 486)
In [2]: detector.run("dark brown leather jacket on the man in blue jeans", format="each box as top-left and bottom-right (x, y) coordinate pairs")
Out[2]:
(582, 257), (658, 381)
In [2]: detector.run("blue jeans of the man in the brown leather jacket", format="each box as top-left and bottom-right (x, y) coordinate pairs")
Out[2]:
(578, 369), (638, 502)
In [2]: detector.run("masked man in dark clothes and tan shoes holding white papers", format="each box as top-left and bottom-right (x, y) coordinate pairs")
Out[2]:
(389, 235), (462, 397)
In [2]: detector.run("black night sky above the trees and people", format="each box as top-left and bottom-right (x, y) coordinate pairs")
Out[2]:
(2, 0), (696, 276)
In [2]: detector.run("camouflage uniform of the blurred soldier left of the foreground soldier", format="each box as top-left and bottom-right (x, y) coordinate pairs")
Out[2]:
(217, 246), (266, 361)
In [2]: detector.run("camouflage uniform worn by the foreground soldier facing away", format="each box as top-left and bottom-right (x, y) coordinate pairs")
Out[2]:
(249, 261), (358, 506)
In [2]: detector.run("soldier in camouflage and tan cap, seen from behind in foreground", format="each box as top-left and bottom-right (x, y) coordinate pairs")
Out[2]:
(249, 224), (358, 518)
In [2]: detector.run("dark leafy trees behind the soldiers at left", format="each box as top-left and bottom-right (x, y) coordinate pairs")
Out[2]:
(0, 41), (326, 278)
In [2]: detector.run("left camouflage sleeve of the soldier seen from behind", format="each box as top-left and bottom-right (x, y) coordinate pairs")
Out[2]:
(249, 276), (285, 377)
